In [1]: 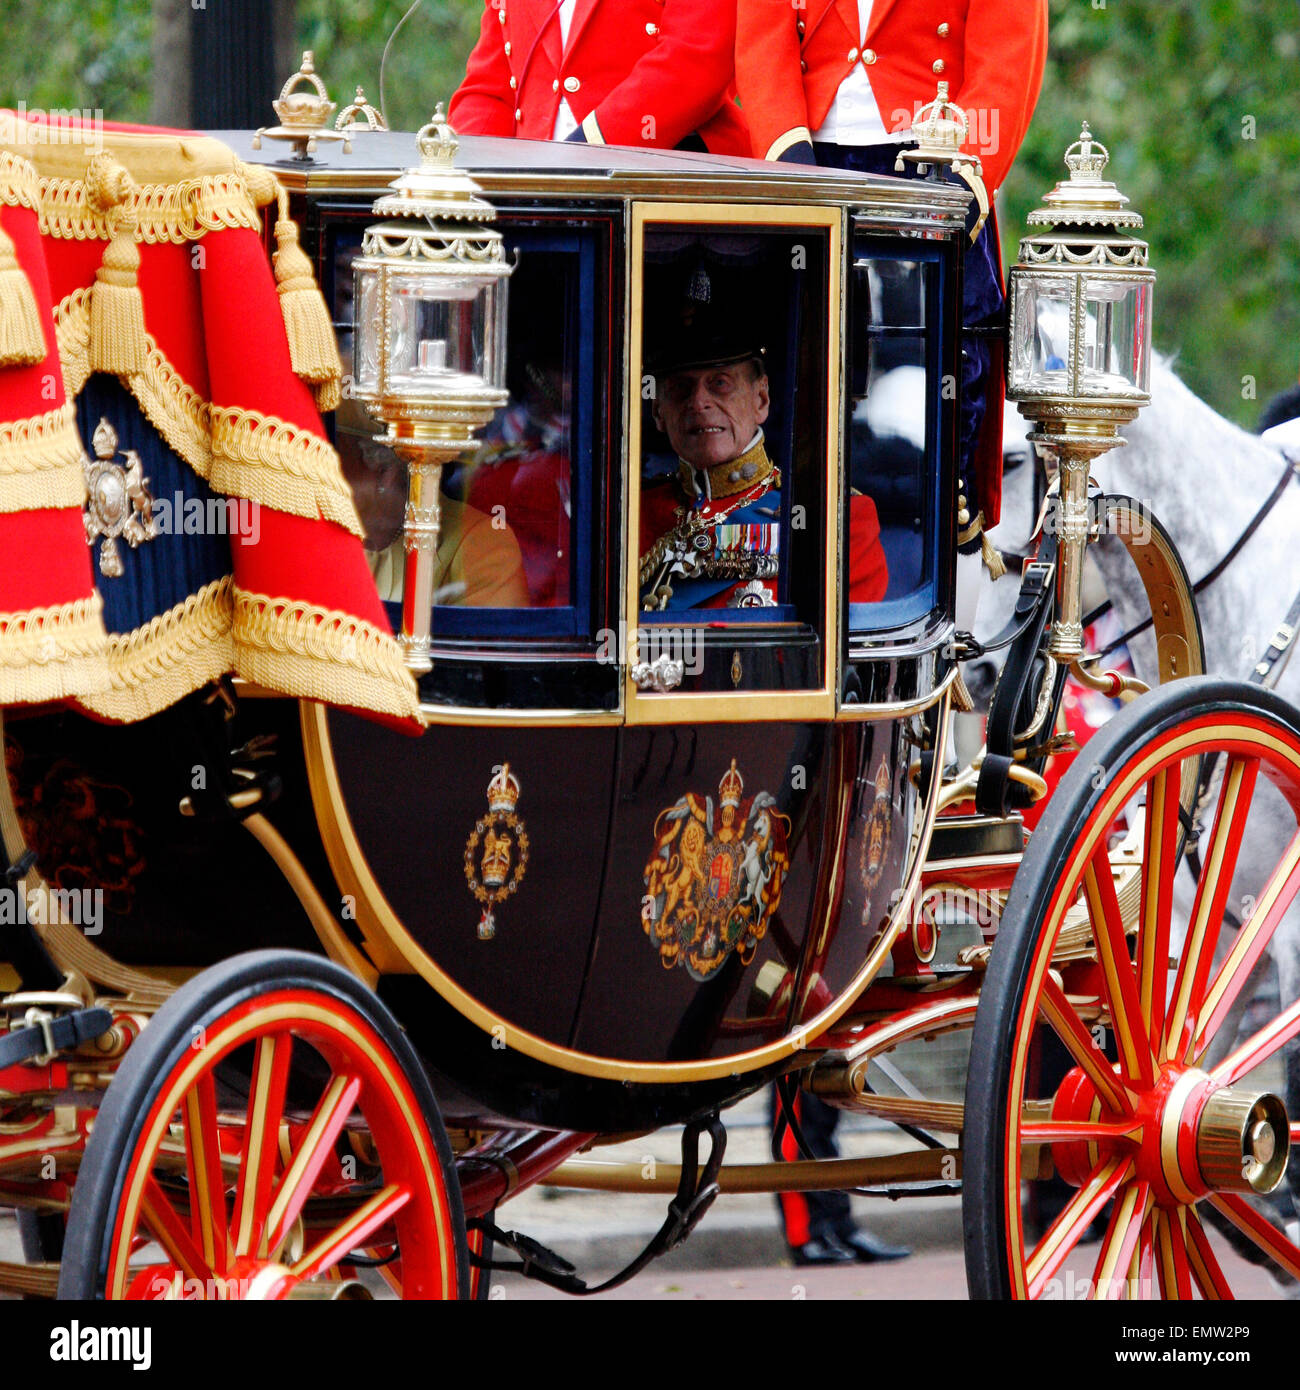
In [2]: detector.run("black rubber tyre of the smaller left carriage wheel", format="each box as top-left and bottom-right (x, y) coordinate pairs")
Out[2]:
(58, 951), (469, 1300)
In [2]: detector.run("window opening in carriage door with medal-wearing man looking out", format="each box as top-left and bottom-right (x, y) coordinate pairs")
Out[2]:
(638, 228), (826, 624)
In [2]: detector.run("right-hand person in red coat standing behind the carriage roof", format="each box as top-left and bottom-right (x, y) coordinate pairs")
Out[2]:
(736, 0), (1047, 552)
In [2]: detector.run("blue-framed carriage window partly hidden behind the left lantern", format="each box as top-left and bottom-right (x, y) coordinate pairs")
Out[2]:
(335, 228), (599, 642)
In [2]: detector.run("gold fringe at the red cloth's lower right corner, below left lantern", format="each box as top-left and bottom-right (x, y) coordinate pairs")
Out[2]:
(235, 588), (420, 720)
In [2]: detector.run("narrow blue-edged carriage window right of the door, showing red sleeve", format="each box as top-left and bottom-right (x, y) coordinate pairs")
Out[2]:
(847, 243), (943, 628)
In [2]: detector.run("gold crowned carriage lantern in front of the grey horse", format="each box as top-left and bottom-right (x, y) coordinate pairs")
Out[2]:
(1007, 122), (1155, 662)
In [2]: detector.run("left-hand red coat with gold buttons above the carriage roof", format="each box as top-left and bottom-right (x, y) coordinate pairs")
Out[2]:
(449, 0), (749, 154)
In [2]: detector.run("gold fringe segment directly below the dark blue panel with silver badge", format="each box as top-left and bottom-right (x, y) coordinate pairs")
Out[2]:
(79, 575), (235, 723)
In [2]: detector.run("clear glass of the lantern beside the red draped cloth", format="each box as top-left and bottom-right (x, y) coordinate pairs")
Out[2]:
(388, 274), (496, 400)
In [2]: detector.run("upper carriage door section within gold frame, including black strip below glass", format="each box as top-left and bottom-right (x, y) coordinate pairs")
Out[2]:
(628, 207), (838, 717)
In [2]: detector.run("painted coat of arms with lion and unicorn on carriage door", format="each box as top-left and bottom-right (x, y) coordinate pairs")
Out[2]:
(641, 758), (790, 980)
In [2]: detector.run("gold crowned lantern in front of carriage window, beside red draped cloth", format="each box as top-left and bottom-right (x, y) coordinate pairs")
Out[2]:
(353, 104), (513, 671)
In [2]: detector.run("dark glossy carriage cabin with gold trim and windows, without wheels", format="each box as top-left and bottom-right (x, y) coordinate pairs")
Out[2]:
(221, 127), (965, 1130)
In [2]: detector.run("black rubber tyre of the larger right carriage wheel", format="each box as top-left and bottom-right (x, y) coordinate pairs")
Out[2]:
(962, 676), (1300, 1298)
